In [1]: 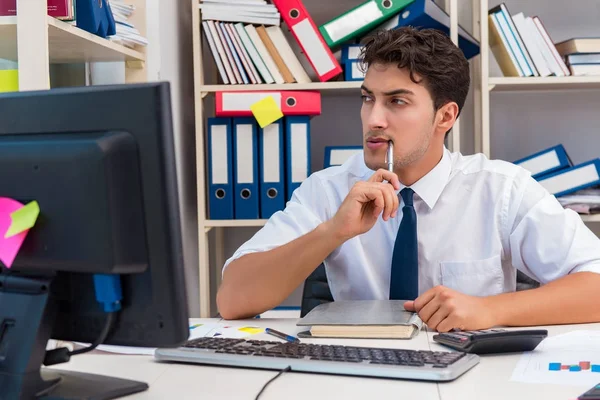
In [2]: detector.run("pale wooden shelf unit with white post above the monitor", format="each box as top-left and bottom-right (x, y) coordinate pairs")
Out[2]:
(0, 0), (147, 90)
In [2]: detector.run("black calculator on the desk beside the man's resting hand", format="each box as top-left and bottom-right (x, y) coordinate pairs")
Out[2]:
(433, 329), (548, 354)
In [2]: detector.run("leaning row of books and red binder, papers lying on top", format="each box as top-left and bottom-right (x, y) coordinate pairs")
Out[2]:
(199, 0), (342, 84)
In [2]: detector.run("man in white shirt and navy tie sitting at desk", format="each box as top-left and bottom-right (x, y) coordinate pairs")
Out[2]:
(217, 28), (600, 332)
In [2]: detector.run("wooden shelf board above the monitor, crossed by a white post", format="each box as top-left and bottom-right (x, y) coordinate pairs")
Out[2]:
(0, 16), (145, 64)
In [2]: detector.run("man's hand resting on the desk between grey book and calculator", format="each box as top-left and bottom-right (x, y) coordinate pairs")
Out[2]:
(404, 286), (495, 332)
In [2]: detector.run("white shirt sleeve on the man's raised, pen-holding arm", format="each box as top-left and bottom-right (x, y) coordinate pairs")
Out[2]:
(222, 174), (332, 272)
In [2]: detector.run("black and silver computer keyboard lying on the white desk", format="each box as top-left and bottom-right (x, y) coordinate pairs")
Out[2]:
(154, 337), (479, 381)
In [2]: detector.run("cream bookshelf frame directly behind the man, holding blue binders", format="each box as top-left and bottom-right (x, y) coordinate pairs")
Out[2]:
(190, 0), (461, 317)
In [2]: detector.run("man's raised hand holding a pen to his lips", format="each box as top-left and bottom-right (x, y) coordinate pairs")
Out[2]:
(328, 169), (400, 240)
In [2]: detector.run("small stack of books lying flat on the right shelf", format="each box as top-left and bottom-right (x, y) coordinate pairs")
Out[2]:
(556, 38), (600, 75)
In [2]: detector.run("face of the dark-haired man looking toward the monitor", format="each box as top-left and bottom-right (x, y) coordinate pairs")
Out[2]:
(360, 64), (435, 170)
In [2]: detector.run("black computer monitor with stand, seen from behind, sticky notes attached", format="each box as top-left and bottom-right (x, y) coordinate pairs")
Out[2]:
(0, 82), (189, 399)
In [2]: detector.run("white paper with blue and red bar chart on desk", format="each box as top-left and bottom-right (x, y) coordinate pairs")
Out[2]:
(511, 330), (600, 386)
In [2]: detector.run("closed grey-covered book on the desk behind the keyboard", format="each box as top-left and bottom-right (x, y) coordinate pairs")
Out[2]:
(296, 300), (423, 339)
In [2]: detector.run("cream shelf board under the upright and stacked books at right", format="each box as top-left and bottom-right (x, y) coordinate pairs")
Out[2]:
(488, 76), (600, 92)
